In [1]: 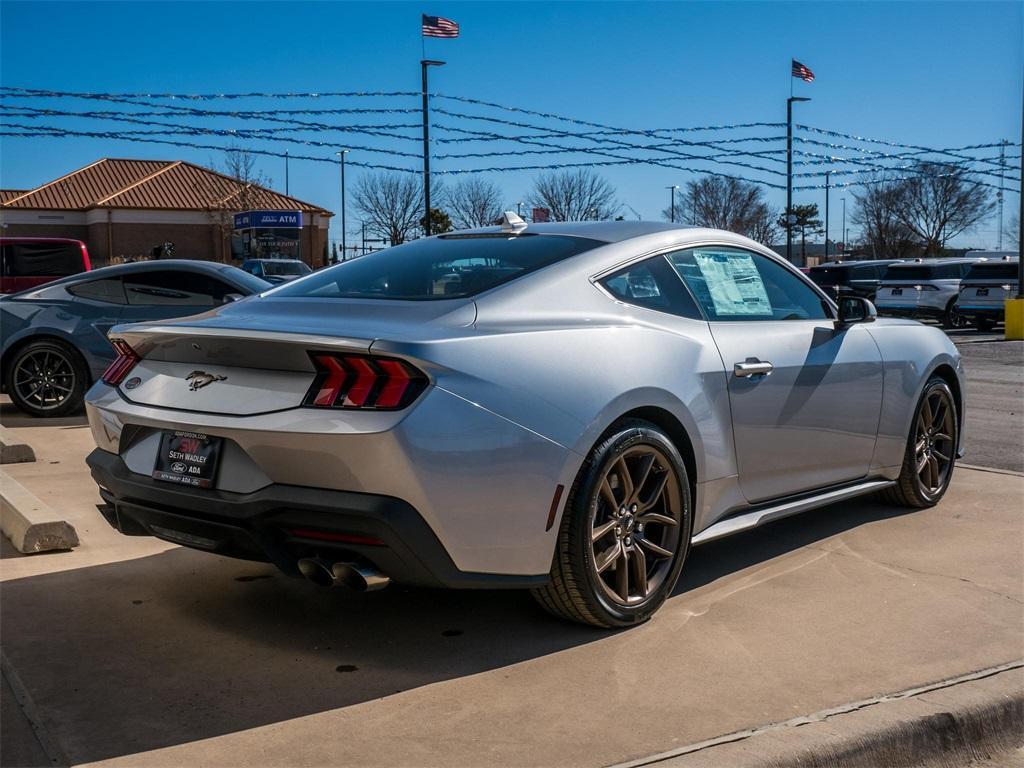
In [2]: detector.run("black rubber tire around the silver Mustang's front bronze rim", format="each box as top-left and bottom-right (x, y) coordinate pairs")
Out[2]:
(882, 376), (959, 509)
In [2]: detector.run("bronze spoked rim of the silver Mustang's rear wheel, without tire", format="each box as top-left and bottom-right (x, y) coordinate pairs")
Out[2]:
(590, 443), (682, 605)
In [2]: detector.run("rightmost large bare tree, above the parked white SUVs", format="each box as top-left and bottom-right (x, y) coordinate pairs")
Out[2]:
(893, 161), (995, 256)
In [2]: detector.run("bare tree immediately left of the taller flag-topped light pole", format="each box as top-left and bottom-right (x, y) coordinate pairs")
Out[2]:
(352, 171), (423, 246)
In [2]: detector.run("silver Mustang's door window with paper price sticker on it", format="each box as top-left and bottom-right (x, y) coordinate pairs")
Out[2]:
(669, 247), (828, 322)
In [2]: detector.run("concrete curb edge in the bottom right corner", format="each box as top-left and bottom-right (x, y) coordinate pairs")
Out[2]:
(612, 660), (1024, 768)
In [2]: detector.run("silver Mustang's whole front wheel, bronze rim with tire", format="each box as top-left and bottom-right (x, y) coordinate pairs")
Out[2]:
(883, 376), (959, 508)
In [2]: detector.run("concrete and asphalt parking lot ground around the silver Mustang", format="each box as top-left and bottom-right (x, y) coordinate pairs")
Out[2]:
(0, 335), (1024, 766)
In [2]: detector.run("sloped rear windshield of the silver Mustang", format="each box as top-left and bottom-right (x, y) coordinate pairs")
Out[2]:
(273, 233), (605, 300)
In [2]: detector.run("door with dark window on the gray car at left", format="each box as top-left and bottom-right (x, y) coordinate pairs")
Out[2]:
(121, 269), (238, 323)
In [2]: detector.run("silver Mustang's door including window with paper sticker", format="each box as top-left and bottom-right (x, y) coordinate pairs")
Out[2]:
(670, 246), (882, 504)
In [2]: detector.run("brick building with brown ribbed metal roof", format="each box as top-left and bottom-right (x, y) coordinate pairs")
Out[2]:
(0, 158), (333, 268)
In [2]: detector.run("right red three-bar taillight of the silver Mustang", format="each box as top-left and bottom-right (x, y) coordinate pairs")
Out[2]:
(303, 352), (427, 411)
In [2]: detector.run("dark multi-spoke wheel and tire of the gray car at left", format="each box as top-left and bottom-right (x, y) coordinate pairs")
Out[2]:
(4, 340), (89, 417)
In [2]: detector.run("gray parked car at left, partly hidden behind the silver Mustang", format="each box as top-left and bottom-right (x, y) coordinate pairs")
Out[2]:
(0, 259), (270, 416)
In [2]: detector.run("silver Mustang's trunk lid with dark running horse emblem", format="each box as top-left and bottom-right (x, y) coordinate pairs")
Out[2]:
(110, 296), (476, 416)
